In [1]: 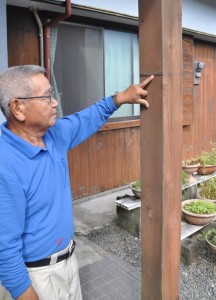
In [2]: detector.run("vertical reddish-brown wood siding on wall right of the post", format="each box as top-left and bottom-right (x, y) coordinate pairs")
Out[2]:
(183, 41), (216, 158)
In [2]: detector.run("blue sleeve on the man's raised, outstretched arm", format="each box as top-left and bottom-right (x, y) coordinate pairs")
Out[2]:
(52, 96), (118, 151)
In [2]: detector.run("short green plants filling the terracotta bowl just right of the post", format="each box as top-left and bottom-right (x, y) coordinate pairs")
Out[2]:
(184, 200), (216, 215)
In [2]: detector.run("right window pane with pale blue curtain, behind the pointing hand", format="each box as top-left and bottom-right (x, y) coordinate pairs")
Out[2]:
(104, 30), (139, 118)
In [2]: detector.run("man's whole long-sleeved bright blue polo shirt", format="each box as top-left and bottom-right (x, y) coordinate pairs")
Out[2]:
(0, 97), (117, 298)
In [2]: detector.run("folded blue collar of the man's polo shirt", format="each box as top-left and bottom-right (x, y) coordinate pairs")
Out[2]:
(1, 121), (47, 158)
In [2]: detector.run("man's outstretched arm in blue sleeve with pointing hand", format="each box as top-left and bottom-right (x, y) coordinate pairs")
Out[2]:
(54, 75), (154, 151)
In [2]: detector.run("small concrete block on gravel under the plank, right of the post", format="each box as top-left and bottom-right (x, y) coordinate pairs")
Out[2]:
(181, 238), (198, 265)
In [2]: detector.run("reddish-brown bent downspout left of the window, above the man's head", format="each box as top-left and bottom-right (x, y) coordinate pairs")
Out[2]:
(43, 0), (72, 81)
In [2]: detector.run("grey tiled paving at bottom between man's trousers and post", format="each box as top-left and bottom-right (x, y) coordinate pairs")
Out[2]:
(80, 255), (141, 300)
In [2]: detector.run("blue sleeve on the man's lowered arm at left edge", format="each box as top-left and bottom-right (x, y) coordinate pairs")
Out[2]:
(0, 174), (31, 298)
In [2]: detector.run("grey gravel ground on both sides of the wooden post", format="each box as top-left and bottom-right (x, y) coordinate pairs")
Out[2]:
(87, 222), (216, 300)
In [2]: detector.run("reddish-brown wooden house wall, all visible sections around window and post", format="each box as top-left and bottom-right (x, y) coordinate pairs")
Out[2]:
(7, 6), (216, 199)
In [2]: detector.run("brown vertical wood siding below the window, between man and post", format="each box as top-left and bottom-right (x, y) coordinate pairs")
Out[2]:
(68, 127), (140, 199)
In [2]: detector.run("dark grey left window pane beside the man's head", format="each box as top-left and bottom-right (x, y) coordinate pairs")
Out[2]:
(54, 24), (104, 115)
